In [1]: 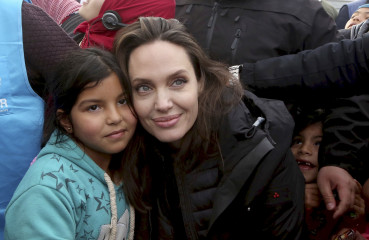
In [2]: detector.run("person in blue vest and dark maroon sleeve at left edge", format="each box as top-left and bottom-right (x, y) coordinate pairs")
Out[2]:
(0, 0), (79, 238)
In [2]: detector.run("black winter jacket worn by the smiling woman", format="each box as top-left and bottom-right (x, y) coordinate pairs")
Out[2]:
(136, 92), (304, 239)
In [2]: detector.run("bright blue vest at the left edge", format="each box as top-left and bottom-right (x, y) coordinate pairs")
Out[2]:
(0, 0), (44, 239)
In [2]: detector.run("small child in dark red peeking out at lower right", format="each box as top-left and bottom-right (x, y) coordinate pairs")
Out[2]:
(291, 109), (365, 240)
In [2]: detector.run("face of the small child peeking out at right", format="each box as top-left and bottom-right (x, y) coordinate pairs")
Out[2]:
(291, 122), (323, 183)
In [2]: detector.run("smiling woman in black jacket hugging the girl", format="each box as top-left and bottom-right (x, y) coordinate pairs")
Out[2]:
(113, 17), (304, 239)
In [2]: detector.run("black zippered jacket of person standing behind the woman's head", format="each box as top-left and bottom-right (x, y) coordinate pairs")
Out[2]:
(176, 0), (339, 65)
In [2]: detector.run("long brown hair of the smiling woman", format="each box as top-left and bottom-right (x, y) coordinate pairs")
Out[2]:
(113, 17), (243, 210)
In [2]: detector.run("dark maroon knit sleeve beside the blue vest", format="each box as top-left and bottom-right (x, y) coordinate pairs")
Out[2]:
(22, 2), (79, 97)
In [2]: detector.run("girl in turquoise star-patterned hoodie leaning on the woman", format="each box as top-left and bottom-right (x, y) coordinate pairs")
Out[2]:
(4, 48), (137, 240)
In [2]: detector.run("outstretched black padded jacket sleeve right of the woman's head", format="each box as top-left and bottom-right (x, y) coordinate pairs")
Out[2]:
(240, 36), (369, 100)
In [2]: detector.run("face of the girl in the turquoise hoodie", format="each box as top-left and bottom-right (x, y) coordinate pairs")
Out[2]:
(63, 73), (137, 170)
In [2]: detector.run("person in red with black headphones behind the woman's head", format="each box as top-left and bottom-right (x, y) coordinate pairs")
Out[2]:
(32, 0), (175, 50)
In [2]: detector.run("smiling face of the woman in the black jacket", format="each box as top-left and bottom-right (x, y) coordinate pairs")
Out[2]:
(128, 40), (201, 145)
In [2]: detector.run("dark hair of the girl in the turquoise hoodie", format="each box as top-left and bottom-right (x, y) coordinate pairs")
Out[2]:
(43, 48), (133, 145)
